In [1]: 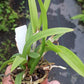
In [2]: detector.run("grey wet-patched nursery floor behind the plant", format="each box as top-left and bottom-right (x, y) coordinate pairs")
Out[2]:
(45, 0), (84, 84)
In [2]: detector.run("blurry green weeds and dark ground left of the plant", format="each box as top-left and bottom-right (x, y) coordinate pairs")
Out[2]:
(0, 0), (29, 77)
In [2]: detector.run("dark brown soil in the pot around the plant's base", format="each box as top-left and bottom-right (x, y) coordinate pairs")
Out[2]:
(11, 68), (45, 81)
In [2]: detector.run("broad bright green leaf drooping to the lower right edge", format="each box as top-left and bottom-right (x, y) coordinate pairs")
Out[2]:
(46, 40), (84, 77)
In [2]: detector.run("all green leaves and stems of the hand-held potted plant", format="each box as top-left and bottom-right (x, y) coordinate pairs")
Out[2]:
(0, 0), (84, 84)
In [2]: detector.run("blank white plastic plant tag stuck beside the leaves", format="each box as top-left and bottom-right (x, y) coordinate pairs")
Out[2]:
(15, 25), (27, 54)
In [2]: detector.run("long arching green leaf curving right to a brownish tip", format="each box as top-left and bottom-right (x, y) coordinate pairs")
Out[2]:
(22, 27), (73, 58)
